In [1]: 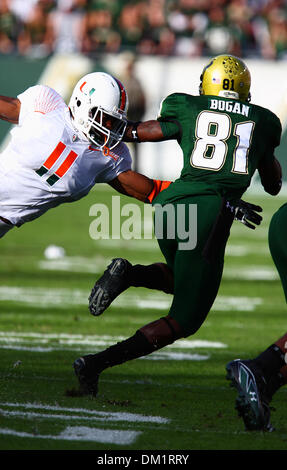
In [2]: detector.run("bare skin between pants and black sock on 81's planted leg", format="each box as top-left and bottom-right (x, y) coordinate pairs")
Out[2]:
(139, 315), (184, 350)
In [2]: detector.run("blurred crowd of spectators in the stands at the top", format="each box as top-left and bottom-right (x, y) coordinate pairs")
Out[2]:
(0, 0), (287, 60)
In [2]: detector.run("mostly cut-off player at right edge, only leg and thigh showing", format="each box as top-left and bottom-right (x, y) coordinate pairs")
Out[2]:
(226, 204), (287, 431)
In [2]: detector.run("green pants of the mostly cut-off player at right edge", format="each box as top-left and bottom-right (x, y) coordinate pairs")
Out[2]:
(268, 204), (287, 302)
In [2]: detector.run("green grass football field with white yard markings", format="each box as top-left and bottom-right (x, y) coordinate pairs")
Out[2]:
(0, 185), (287, 450)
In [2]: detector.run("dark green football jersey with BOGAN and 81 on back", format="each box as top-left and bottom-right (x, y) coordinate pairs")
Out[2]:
(155, 93), (281, 203)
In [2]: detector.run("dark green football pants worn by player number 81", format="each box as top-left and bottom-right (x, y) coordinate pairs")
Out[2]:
(155, 195), (233, 336)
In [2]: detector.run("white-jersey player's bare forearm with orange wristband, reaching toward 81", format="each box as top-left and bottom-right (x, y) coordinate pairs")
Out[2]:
(109, 170), (171, 203)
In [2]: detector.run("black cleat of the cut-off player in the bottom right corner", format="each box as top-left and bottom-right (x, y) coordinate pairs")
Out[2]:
(226, 359), (274, 432)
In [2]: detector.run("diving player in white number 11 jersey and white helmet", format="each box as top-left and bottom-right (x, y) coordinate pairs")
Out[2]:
(0, 72), (169, 237)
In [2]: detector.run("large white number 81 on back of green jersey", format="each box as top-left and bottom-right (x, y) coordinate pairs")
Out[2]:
(190, 111), (255, 174)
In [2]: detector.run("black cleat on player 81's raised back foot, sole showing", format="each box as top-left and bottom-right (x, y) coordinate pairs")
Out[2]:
(89, 258), (131, 317)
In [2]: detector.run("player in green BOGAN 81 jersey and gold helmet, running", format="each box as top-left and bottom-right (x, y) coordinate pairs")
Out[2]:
(74, 56), (282, 404)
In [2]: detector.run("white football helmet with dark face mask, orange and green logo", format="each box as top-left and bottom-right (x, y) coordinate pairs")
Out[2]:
(69, 72), (128, 149)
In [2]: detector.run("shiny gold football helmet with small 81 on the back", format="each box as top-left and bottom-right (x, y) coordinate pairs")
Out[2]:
(199, 55), (251, 101)
